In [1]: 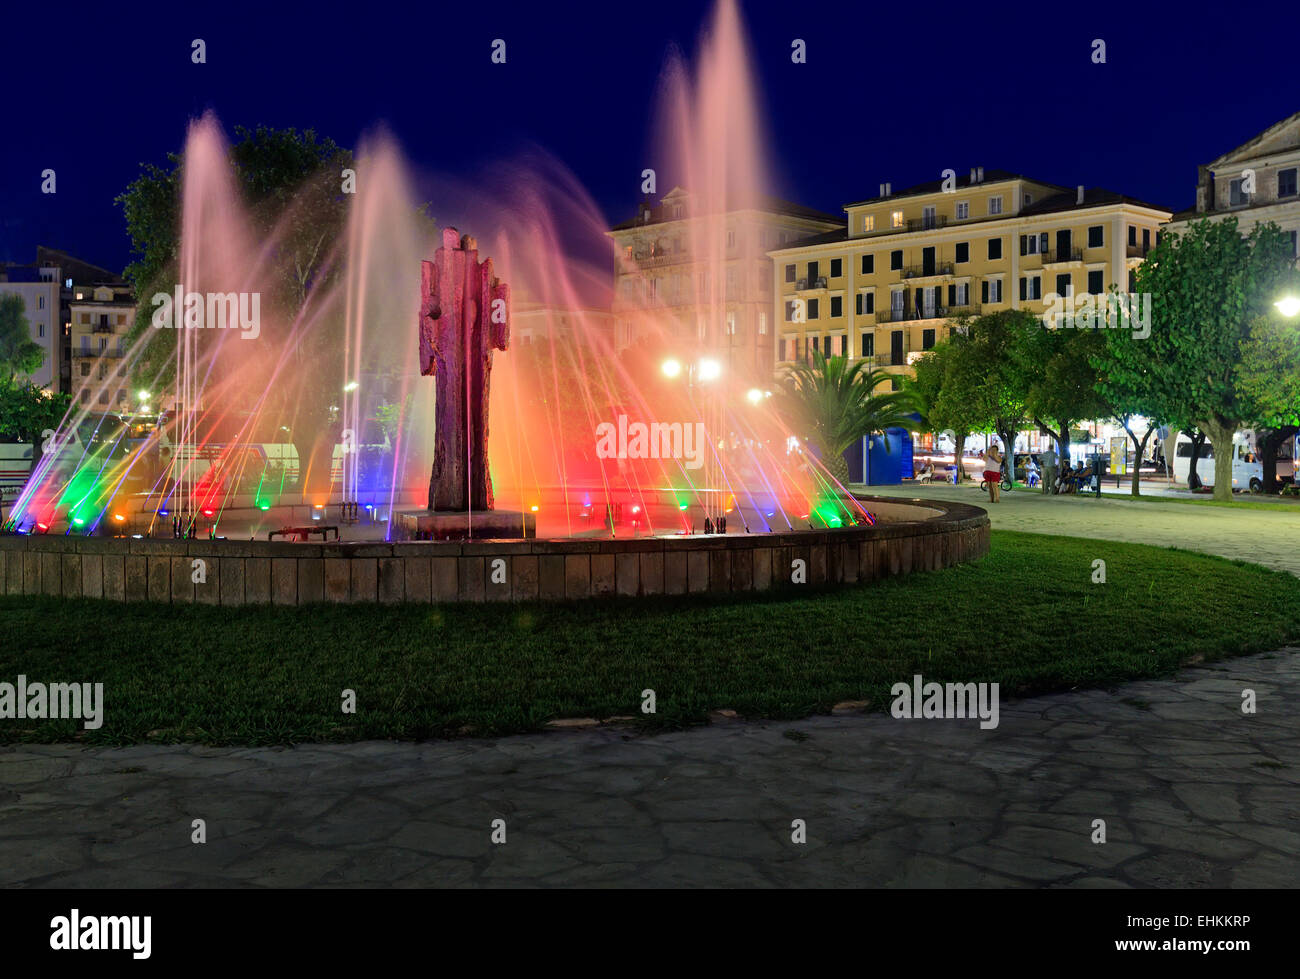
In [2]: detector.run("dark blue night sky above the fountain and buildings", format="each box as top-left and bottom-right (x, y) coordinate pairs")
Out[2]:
(0, 0), (1300, 269)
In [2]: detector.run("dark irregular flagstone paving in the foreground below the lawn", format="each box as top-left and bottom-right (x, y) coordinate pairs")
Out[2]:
(0, 649), (1300, 887)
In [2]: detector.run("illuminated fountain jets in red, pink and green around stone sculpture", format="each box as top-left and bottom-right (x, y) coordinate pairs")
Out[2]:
(7, 0), (971, 597)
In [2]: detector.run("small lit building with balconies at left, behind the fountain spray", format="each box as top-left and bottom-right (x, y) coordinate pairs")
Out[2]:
(69, 285), (135, 411)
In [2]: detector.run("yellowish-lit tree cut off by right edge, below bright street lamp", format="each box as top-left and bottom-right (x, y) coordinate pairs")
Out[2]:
(1236, 311), (1300, 493)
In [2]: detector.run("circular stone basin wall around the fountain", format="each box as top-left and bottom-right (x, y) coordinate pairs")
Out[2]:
(0, 495), (989, 606)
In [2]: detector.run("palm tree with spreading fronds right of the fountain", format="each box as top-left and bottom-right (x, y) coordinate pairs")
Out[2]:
(775, 351), (917, 486)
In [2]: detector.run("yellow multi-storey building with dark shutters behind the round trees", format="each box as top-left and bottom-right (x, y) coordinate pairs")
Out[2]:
(770, 166), (1170, 387)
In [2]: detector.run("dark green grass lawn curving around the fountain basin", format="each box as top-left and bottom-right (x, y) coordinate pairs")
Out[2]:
(0, 530), (1300, 744)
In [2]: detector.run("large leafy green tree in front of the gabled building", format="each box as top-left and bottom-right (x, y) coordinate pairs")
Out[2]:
(1097, 217), (1294, 501)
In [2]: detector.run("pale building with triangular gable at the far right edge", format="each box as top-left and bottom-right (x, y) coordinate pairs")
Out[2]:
(1169, 112), (1300, 254)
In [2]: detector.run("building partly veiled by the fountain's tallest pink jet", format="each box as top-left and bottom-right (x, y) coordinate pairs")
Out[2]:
(610, 187), (844, 377)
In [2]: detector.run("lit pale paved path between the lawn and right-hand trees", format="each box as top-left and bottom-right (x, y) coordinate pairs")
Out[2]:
(861, 484), (1300, 575)
